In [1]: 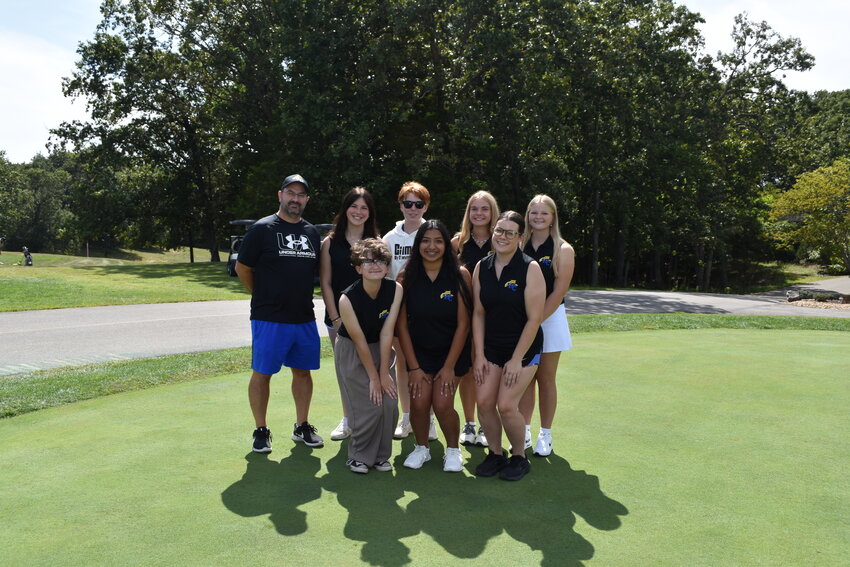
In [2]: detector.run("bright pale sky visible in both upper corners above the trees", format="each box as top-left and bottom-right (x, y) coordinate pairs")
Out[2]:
(0, 0), (850, 163)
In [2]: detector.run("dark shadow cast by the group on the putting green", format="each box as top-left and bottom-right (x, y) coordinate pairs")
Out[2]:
(222, 440), (628, 567)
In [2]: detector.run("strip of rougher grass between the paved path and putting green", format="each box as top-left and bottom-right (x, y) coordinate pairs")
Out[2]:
(0, 313), (850, 417)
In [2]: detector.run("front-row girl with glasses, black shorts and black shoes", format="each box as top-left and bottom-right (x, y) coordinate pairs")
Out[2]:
(472, 211), (546, 480)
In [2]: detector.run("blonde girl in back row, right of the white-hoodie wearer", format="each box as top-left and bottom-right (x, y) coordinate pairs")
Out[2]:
(452, 191), (499, 447)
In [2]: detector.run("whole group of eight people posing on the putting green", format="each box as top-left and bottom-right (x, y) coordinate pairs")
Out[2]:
(237, 175), (574, 480)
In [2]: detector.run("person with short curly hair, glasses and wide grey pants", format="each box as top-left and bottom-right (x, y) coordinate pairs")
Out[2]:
(334, 238), (402, 474)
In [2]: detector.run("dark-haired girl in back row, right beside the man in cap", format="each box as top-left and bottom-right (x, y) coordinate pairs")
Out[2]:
(319, 187), (379, 441)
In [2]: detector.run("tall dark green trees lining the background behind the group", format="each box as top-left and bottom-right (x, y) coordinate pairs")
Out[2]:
(0, 0), (850, 284)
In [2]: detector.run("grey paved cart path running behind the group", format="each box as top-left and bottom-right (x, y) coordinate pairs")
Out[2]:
(0, 277), (850, 376)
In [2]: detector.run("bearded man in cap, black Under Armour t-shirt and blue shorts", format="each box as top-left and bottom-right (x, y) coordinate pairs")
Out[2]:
(236, 175), (324, 453)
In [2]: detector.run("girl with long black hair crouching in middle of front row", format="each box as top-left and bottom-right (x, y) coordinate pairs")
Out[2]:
(398, 220), (472, 472)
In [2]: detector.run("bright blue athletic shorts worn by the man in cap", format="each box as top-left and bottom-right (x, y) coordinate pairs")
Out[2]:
(251, 320), (320, 374)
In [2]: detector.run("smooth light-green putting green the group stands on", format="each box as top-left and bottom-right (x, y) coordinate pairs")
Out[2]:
(0, 330), (850, 567)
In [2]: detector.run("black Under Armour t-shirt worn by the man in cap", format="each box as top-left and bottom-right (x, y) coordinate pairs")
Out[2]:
(239, 214), (320, 324)
